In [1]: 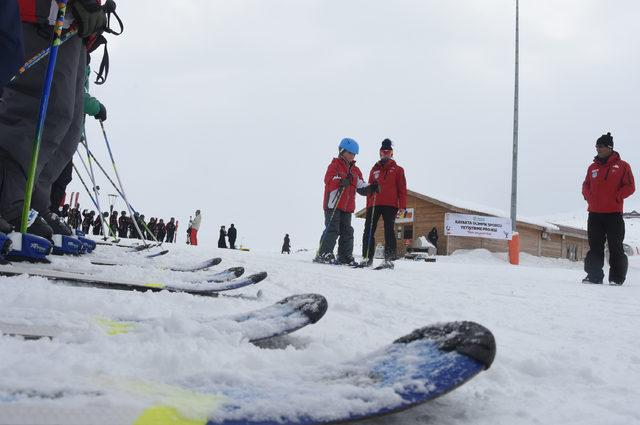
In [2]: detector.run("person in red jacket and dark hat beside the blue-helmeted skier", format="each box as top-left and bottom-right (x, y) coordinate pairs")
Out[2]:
(362, 139), (407, 266)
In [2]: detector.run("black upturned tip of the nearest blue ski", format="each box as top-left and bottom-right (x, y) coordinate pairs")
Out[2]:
(394, 321), (496, 369)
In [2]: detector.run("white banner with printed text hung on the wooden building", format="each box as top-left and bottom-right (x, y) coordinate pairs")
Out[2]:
(444, 213), (512, 240)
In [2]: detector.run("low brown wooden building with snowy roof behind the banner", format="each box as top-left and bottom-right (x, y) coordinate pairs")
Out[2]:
(356, 190), (589, 261)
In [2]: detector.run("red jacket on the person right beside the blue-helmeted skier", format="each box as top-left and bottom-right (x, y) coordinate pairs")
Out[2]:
(367, 159), (407, 209)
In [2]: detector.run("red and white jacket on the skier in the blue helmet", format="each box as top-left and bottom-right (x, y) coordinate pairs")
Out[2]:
(322, 158), (367, 213)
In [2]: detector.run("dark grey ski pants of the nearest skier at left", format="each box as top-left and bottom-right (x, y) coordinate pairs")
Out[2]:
(0, 23), (87, 220)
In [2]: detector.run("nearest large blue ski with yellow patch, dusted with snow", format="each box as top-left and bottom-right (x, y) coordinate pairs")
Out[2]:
(0, 322), (496, 425)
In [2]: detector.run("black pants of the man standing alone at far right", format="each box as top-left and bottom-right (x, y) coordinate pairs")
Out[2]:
(584, 213), (629, 283)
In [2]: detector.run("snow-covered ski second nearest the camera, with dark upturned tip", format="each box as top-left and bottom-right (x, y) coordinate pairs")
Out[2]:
(0, 294), (327, 342)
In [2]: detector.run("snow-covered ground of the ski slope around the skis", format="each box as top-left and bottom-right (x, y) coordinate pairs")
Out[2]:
(0, 242), (640, 425)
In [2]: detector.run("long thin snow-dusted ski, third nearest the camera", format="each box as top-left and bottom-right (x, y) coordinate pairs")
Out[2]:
(0, 264), (267, 297)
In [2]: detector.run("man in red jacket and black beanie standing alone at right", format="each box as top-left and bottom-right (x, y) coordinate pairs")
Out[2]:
(582, 133), (636, 285)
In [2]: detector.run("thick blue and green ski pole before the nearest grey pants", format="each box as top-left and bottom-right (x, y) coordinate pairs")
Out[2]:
(20, 0), (67, 233)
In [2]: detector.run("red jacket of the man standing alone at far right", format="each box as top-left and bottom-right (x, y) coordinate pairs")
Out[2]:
(582, 151), (636, 213)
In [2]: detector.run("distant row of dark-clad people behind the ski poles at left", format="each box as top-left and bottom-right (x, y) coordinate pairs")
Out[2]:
(58, 204), (177, 243)
